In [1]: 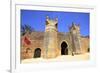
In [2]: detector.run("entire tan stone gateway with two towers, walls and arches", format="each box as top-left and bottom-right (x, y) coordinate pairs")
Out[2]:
(21, 16), (90, 60)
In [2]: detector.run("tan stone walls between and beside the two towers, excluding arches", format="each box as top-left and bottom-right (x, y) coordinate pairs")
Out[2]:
(21, 32), (90, 59)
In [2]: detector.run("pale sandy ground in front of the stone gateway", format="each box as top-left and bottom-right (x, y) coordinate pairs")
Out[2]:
(21, 53), (89, 64)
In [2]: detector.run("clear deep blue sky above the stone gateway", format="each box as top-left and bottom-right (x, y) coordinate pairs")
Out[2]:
(21, 10), (90, 36)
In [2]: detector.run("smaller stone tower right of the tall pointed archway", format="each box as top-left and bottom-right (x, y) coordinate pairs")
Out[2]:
(70, 23), (81, 54)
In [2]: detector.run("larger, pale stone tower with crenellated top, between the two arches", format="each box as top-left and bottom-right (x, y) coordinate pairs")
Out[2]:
(43, 16), (59, 58)
